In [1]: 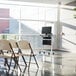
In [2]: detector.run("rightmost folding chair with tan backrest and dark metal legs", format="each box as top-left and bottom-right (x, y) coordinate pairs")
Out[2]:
(17, 40), (39, 70)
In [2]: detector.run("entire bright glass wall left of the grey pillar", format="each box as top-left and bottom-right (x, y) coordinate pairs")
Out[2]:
(0, 2), (57, 47)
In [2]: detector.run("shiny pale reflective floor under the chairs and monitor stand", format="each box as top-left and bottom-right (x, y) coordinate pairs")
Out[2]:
(0, 51), (76, 76)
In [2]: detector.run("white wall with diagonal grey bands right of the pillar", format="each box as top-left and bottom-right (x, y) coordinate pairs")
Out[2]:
(61, 6), (76, 52)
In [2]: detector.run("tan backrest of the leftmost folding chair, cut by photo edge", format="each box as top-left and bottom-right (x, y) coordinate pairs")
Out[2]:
(0, 40), (12, 51)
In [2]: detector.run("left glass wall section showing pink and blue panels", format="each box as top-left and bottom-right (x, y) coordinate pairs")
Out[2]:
(0, 3), (20, 39)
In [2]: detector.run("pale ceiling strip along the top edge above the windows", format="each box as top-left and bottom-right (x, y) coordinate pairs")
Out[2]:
(8, 0), (76, 4)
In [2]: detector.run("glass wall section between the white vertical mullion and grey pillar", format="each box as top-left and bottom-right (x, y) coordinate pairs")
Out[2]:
(20, 6), (57, 47)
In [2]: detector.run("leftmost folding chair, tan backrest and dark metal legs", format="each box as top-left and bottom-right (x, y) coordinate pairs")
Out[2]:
(0, 40), (22, 72)
